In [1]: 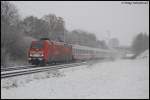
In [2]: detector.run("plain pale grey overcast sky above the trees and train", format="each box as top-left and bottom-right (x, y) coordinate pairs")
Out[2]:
(11, 1), (149, 45)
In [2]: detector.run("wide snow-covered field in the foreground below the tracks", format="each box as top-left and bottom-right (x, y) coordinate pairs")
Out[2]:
(1, 58), (149, 99)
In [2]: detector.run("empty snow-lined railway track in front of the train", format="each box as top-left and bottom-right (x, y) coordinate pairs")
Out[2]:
(1, 62), (88, 79)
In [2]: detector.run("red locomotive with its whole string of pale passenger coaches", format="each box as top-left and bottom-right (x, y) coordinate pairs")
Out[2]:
(28, 38), (115, 65)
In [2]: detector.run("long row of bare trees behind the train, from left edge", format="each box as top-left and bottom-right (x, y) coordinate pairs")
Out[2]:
(1, 1), (107, 65)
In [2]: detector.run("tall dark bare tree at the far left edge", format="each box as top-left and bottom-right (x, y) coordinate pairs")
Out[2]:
(1, 1), (26, 65)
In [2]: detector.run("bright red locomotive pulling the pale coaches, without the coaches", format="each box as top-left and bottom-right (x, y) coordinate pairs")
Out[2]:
(28, 39), (73, 65)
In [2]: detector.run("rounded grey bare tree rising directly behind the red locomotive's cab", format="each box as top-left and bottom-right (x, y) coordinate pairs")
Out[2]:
(23, 16), (50, 39)
